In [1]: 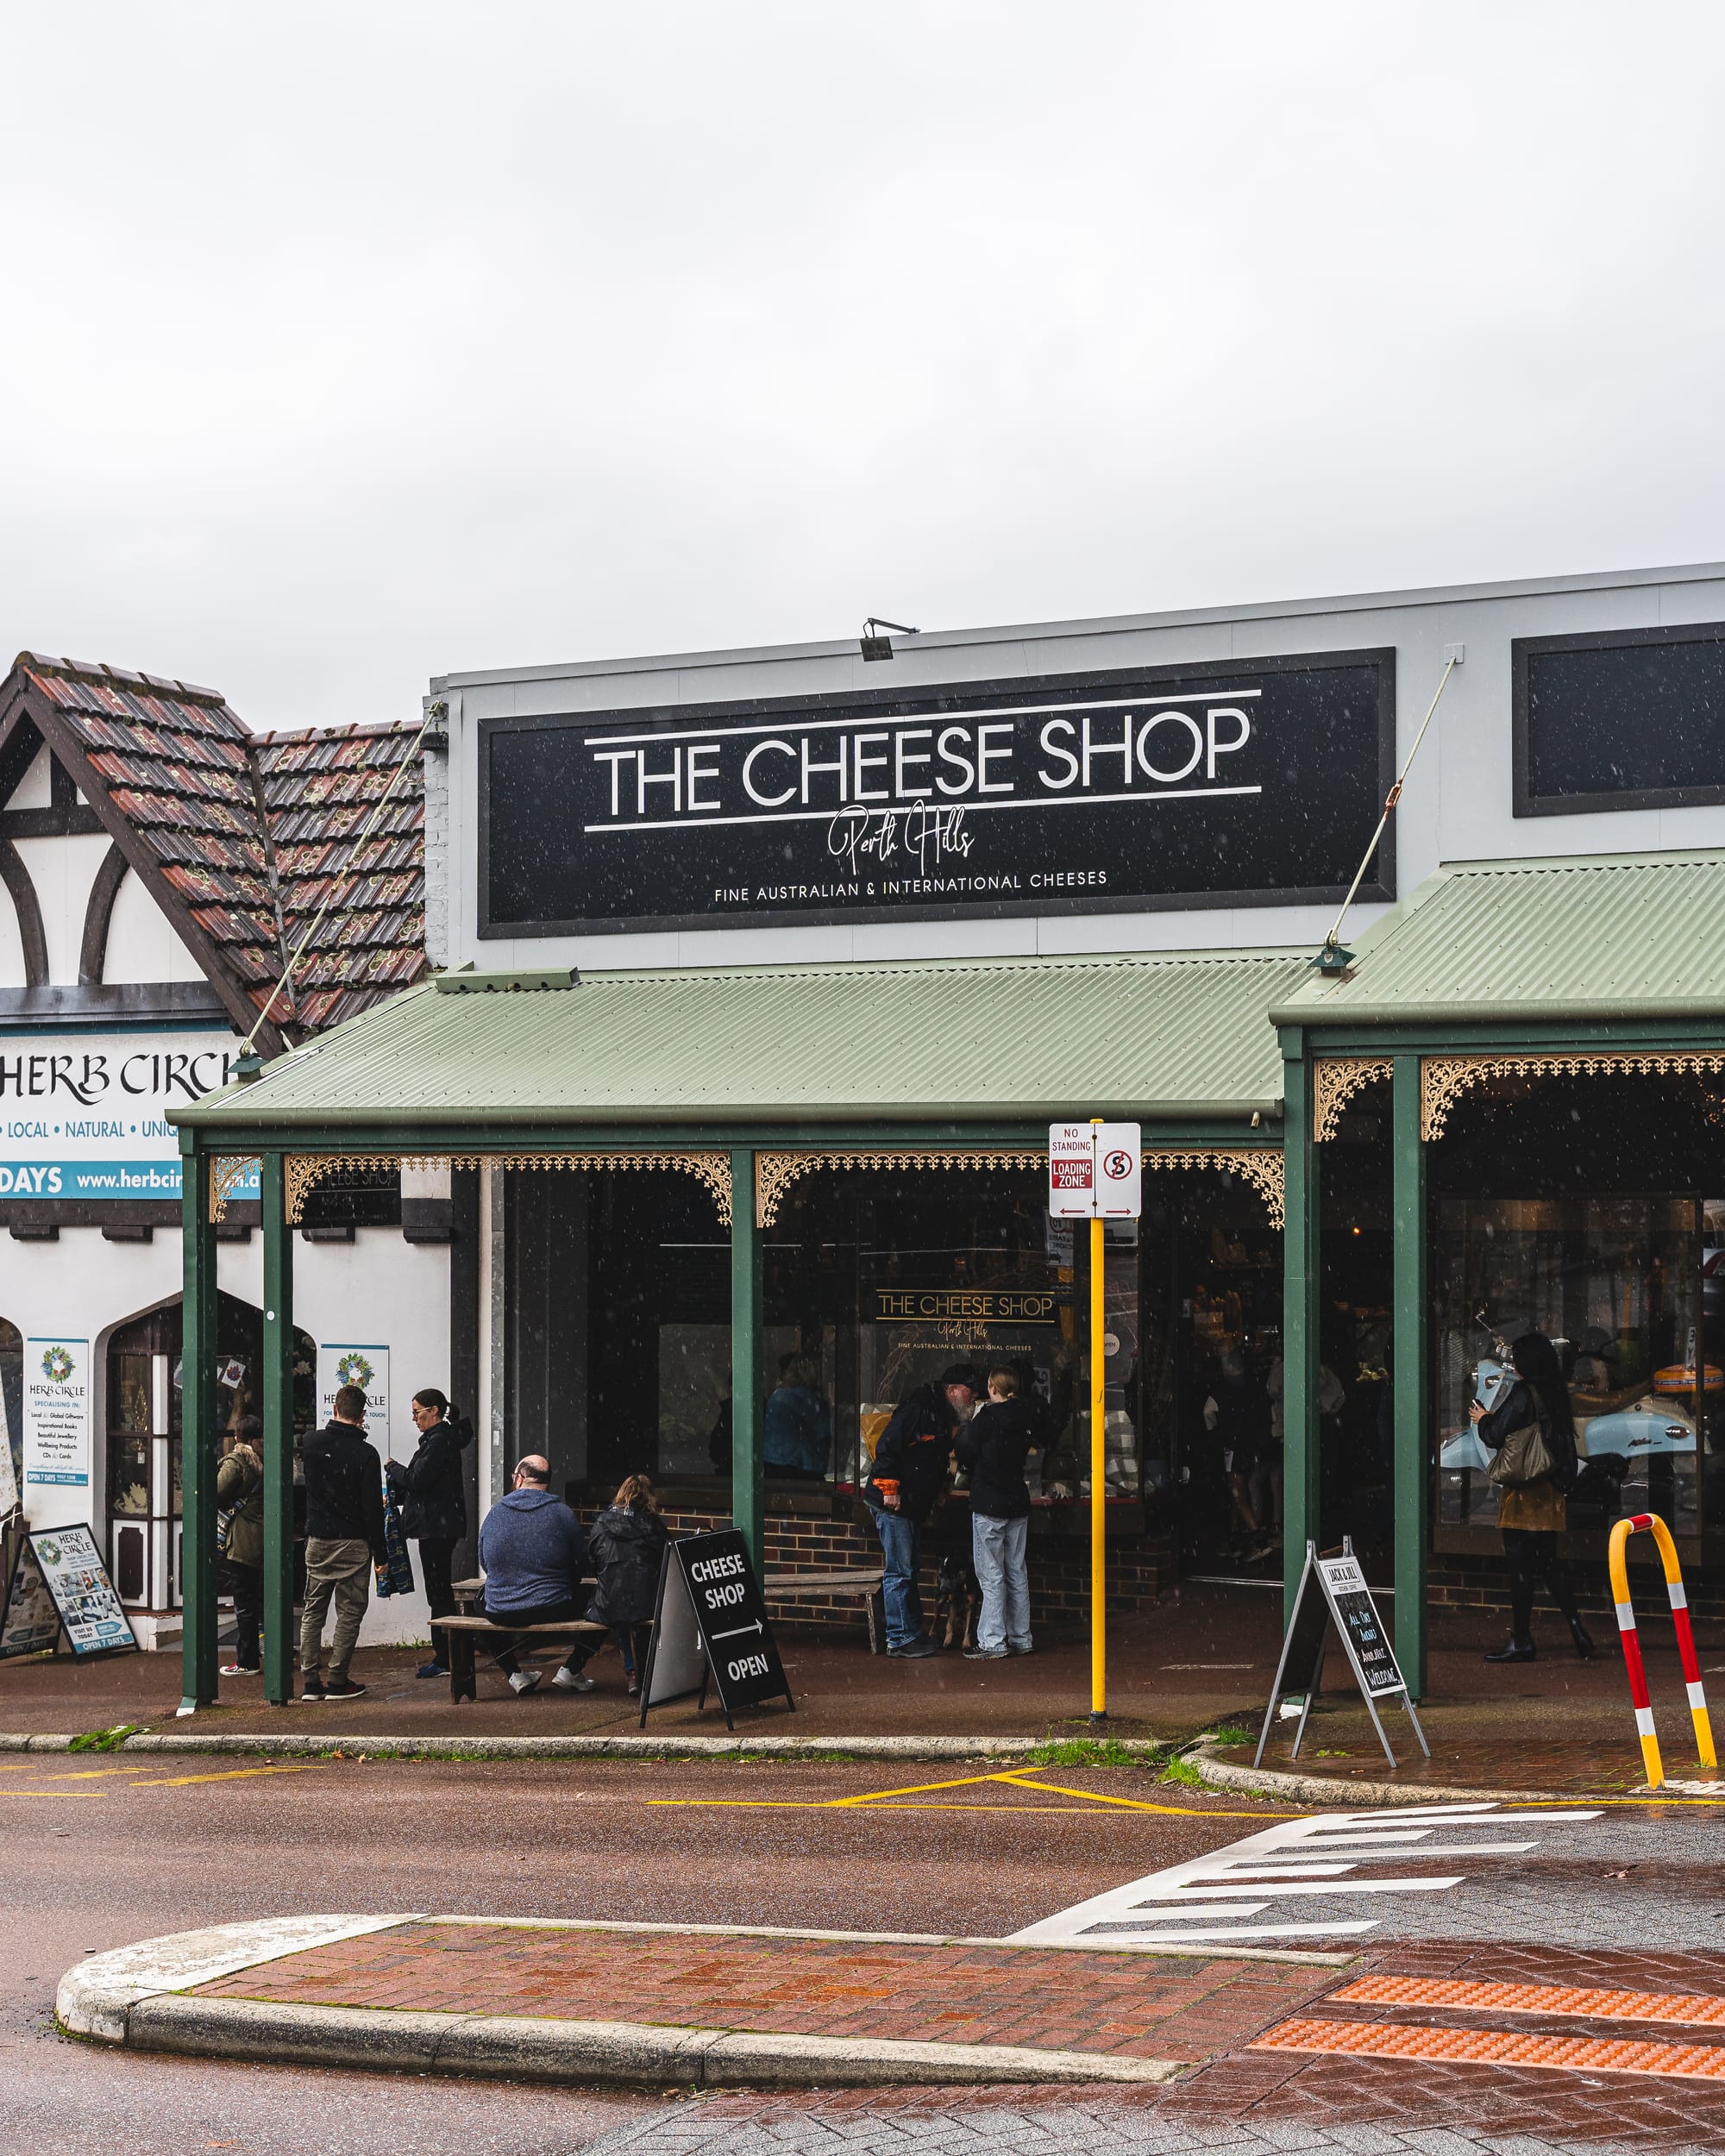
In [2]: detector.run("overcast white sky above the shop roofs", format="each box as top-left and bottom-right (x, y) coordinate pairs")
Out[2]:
(0, 0), (1725, 727)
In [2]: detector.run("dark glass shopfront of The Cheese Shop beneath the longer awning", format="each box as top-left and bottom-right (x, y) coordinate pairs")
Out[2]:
(505, 1163), (1281, 1570)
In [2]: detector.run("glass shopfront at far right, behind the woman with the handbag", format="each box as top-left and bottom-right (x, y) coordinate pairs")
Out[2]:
(1430, 1076), (1725, 1561)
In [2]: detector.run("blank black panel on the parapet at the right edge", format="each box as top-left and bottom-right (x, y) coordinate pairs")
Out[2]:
(1512, 624), (1725, 815)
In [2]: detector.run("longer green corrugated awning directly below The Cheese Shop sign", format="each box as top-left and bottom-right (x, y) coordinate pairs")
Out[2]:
(175, 951), (1302, 1137)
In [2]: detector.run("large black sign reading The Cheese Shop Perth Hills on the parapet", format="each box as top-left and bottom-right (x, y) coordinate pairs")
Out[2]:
(479, 651), (1396, 938)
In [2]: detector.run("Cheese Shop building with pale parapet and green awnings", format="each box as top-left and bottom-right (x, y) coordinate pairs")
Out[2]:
(175, 567), (1725, 1702)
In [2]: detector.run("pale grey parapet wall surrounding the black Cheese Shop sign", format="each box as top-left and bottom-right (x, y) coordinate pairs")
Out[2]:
(434, 565), (1725, 968)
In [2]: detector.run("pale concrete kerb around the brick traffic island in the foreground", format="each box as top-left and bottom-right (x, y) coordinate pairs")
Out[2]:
(56, 1917), (1186, 2090)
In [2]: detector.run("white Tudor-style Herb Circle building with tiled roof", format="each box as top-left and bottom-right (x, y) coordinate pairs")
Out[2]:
(0, 654), (451, 1645)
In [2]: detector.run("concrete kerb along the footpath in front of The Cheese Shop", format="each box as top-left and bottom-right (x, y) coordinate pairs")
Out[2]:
(0, 1729), (1164, 1762)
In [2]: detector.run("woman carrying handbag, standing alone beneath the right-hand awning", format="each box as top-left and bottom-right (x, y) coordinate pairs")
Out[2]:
(1469, 1332), (1594, 1663)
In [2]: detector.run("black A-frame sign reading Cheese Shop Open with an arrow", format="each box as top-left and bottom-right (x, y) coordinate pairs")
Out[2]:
(641, 1526), (796, 1729)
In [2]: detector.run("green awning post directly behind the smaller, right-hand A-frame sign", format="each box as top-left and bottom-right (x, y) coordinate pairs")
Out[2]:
(1281, 1033), (1324, 1621)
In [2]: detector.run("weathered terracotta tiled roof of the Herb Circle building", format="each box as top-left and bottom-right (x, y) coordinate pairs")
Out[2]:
(7, 651), (427, 1037)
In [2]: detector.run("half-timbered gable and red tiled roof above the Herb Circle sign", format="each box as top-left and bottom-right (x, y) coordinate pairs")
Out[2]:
(0, 651), (425, 1052)
